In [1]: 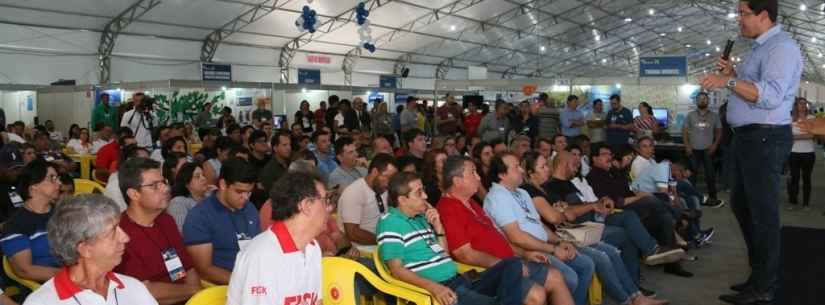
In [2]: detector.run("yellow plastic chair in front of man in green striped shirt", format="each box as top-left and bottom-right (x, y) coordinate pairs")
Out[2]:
(320, 257), (433, 305)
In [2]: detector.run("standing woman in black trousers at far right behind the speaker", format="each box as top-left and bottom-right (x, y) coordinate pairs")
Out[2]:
(788, 98), (816, 212)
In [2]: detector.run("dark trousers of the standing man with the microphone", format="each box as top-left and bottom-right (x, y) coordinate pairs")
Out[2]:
(730, 126), (793, 292)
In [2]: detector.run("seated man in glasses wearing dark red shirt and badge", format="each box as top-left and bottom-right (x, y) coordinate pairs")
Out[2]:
(115, 157), (200, 304)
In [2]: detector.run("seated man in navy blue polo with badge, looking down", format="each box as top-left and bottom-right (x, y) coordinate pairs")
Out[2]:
(183, 158), (261, 285)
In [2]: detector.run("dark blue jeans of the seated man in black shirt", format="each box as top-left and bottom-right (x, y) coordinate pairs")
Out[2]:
(602, 212), (657, 285)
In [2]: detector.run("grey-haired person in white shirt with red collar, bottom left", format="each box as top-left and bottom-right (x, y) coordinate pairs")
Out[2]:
(23, 194), (158, 305)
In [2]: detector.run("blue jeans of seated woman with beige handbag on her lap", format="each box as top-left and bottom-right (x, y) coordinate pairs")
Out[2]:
(578, 242), (639, 304)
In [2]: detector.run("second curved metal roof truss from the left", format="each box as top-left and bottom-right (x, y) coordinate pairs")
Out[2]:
(200, 0), (289, 62)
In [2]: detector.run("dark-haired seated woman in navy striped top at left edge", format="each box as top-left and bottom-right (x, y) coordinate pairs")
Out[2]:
(0, 159), (60, 283)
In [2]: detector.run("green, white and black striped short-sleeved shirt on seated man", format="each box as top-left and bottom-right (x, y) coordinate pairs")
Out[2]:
(376, 208), (458, 283)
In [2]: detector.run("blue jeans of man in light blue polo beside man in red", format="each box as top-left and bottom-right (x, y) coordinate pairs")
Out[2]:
(548, 254), (596, 305)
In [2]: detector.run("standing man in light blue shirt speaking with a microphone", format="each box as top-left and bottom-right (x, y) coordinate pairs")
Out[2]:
(700, 0), (803, 305)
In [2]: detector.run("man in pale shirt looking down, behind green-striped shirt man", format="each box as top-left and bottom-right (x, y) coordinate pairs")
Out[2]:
(338, 154), (398, 246)
